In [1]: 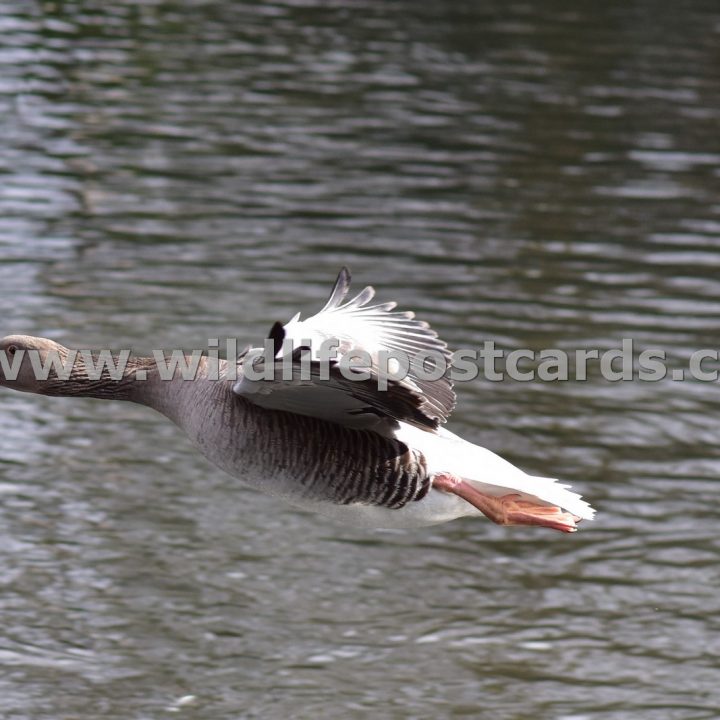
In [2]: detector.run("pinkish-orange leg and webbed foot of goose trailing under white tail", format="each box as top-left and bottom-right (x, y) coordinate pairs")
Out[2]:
(432, 473), (581, 533)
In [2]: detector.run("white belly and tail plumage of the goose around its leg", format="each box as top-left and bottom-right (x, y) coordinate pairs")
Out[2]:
(286, 423), (595, 528)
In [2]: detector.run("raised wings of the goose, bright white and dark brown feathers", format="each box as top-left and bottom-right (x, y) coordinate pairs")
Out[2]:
(233, 268), (455, 431)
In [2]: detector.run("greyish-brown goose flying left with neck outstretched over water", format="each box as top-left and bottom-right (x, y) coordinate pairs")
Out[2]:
(0, 268), (595, 533)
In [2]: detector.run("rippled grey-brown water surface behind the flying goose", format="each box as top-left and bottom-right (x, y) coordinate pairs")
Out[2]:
(0, 0), (720, 720)
